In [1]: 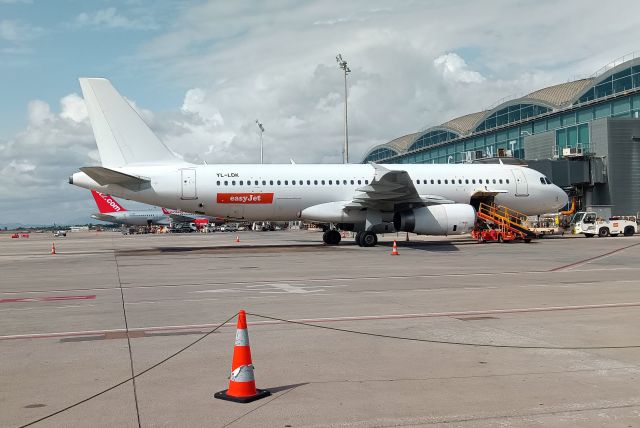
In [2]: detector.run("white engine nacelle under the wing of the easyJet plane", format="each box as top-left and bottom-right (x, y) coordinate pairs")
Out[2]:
(393, 204), (476, 235)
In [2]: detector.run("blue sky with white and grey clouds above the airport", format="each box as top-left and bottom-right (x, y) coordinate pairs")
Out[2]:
(0, 0), (640, 225)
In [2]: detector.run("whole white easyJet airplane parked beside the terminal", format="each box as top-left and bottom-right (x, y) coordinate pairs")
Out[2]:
(69, 78), (568, 247)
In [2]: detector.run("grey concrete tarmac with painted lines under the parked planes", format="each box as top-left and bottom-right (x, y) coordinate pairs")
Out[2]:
(0, 231), (640, 428)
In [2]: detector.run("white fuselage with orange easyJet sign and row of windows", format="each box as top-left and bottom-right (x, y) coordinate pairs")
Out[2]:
(71, 164), (567, 221)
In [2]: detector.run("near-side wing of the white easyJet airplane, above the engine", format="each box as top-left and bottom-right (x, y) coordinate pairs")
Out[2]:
(345, 163), (454, 211)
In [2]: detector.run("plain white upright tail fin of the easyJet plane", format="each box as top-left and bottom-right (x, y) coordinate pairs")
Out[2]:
(79, 78), (184, 167)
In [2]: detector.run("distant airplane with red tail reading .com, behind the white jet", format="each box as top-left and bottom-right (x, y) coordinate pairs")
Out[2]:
(91, 190), (215, 229)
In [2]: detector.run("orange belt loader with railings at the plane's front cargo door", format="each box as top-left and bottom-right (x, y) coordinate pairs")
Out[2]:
(471, 203), (536, 243)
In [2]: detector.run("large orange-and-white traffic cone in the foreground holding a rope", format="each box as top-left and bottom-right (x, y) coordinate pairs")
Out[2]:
(213, 311), (271, 403)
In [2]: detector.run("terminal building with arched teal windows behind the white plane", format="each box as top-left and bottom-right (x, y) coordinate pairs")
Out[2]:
(363, 54), (640, 216)
